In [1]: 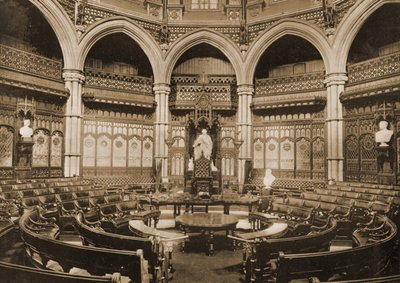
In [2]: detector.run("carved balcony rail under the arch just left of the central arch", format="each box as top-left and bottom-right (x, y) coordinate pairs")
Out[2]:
(85, 71), (153, 95)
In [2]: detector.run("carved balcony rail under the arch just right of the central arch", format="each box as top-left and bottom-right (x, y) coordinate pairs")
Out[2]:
(255, 72), (325, 97)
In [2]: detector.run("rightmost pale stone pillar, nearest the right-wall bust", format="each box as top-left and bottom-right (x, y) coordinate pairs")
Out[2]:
(324, 73), (347, 181)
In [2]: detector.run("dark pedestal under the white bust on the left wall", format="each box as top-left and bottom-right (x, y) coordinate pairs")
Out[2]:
(15, 138), (34, 179)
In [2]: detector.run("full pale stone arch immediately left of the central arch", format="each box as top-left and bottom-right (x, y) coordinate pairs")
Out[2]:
(78, 17), (164, 83)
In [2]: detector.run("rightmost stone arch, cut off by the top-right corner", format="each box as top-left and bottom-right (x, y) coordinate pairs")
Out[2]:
(333, 0), (400, 73)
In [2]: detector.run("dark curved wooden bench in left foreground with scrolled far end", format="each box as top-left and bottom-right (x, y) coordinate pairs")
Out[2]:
(19, 208), (148, 282)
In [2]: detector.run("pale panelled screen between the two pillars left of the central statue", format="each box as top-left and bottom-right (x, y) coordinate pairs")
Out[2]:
(82, 119), (154, 178)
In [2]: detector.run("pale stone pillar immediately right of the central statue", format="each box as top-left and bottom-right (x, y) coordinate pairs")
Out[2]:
(236, 84), (254, 189)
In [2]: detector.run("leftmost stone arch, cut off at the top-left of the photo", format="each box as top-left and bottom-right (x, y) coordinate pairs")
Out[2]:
(29, 0), (78, 69)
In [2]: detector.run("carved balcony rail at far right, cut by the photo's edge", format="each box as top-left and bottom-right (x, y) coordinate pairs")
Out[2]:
(347, 52), (400, 84)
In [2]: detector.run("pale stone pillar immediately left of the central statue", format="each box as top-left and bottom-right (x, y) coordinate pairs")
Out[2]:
(153, 83), (170, 183)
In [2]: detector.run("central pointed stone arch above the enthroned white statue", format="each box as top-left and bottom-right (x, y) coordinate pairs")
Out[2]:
(164, 28), (245, 85)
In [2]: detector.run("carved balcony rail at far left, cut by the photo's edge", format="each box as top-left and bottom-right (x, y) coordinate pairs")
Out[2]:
(0, 44), (62, 81)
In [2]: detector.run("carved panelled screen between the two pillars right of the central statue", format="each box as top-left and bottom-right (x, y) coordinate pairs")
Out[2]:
(253, 111), (326, 182)
